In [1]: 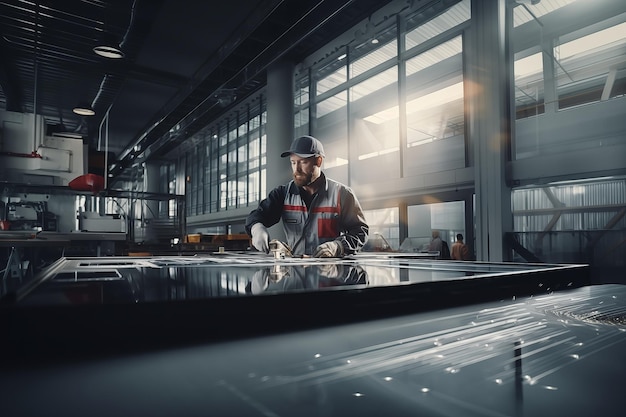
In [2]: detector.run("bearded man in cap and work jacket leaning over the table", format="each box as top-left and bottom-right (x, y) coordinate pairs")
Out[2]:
(246, 136), (369, 258)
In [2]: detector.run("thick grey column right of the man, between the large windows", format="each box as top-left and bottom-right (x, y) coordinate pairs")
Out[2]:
(465, 0), (514, 262)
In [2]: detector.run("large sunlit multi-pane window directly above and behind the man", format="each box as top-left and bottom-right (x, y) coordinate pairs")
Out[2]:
(302, 0), (470, 186)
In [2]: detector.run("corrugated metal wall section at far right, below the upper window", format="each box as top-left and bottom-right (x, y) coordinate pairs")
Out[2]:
(511, 178), (626, 267)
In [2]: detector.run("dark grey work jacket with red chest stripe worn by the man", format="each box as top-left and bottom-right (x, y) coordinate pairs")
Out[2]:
(246, 173), (369, 255)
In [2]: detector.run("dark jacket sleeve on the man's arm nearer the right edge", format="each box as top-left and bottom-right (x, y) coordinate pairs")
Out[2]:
(338, 187), (369, 255)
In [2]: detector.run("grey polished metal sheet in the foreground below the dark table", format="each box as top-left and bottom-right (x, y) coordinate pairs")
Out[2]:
(0, 285), (626, 417)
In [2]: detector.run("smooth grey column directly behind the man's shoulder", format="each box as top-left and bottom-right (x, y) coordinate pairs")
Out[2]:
(266, 61), (294, 240)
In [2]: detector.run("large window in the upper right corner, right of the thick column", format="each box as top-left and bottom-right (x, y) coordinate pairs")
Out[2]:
(512, 0), (626, 159)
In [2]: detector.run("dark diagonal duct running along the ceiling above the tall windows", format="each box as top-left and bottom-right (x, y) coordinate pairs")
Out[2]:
(111, 0), (388, 182)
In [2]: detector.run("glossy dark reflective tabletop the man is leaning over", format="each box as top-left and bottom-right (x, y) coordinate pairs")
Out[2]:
(4, 252), (586, 305)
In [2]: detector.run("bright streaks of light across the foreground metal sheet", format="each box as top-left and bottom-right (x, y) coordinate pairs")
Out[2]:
(260, 294), (626, 385)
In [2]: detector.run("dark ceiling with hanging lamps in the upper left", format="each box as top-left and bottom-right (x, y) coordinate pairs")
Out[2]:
(0, 0), (390, 185)
